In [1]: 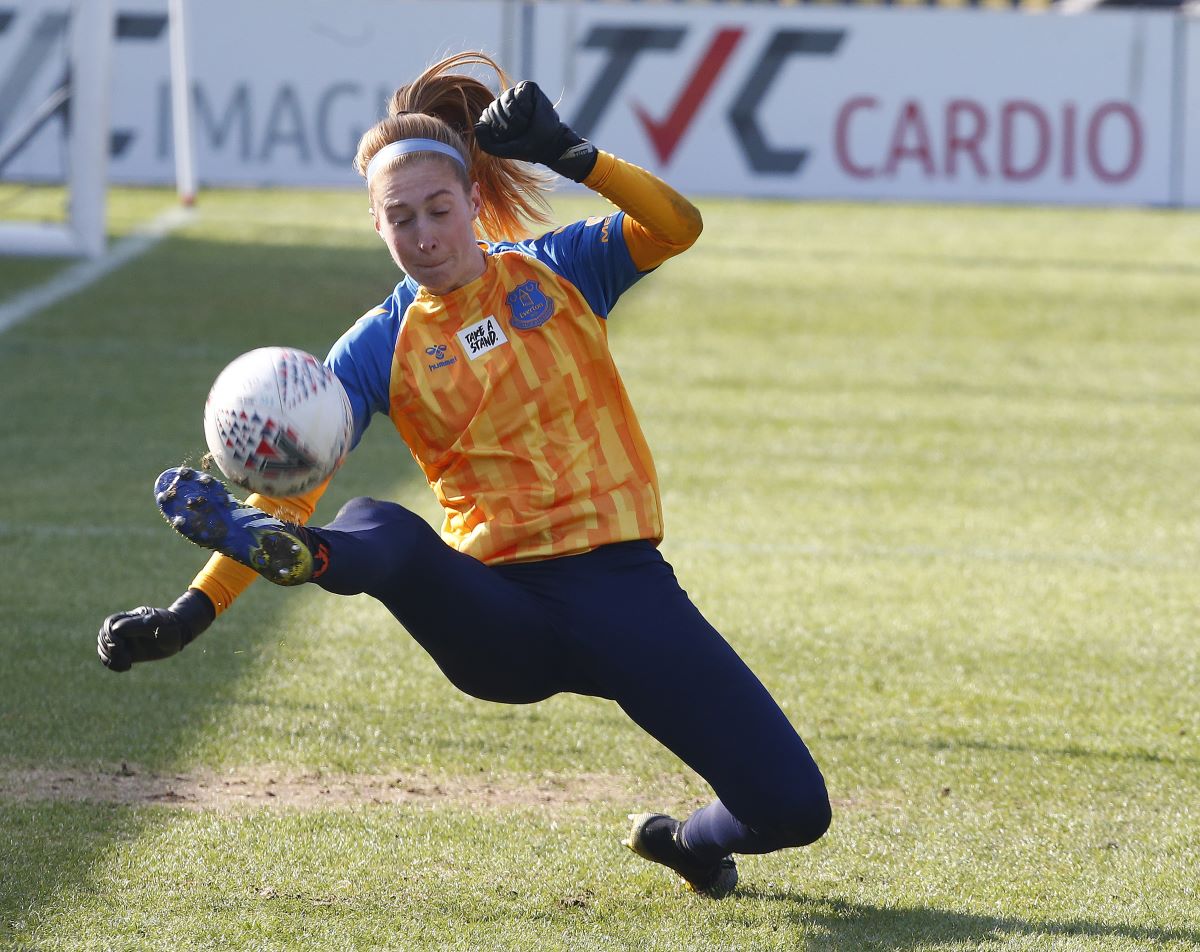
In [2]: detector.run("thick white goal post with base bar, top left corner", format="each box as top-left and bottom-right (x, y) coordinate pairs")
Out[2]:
(0, 0), (113, 257)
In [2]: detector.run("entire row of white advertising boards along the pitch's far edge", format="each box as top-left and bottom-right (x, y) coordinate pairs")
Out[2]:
(0, 0), (1180, 204)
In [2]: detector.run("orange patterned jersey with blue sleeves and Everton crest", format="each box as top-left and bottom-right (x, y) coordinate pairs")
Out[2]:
(326, 212), (662, 563)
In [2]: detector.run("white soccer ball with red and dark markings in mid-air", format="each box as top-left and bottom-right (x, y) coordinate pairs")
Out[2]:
(204, 347), (354, 496)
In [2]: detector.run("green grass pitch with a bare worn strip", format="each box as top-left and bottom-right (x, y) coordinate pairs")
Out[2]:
(0, 190), (1200, 952)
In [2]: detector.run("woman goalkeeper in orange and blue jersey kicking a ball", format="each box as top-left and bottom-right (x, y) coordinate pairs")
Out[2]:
(98, 53), (830, 898)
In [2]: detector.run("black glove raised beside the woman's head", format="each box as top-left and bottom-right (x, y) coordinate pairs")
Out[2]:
(475, 79), (596, 181)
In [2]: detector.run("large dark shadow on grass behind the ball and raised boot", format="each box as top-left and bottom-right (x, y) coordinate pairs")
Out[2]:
(0, 228), (418, 938)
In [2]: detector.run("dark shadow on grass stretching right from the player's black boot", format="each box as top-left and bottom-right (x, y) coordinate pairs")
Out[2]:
(738, 886), (1200, 952)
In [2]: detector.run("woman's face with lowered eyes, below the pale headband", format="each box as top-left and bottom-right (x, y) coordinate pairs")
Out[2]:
(371, 156), (485, 294)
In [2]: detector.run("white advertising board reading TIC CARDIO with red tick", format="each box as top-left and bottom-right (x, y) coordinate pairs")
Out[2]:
(534, 4), (1174, 203)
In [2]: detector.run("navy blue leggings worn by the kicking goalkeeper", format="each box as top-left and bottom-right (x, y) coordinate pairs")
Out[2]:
(310, 497), (830, 861)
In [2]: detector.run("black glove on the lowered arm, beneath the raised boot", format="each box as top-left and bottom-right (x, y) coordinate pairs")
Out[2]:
(96, 588), (216, 671)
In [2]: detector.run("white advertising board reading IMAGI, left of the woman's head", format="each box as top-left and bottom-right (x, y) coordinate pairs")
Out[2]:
(105, 0), (511, 186)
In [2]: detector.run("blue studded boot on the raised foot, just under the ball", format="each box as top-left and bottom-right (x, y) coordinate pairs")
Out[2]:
(154, 466), (312, 585)
